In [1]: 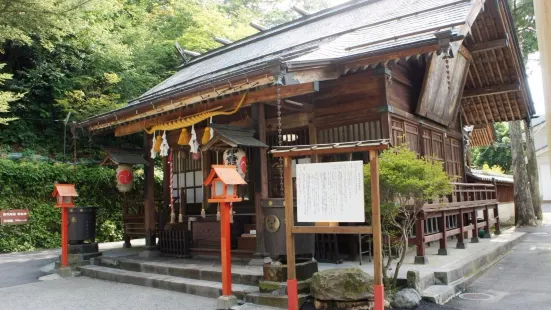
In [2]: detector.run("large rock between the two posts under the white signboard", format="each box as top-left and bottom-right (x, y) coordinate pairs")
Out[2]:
(310, 268), (373, 301)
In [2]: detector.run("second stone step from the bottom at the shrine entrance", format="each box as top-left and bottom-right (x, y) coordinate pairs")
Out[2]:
(91, 257), (263, 286)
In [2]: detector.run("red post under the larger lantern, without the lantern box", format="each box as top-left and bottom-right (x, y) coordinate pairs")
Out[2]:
(220, 202), (232, 296)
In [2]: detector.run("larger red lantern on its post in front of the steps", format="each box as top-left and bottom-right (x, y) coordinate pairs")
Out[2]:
(203, 165), (247, 309)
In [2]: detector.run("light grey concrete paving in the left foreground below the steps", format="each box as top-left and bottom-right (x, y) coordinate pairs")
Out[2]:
(0, 277), (280, 310)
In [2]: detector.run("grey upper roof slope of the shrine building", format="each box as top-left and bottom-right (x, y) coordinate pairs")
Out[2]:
(130, 0), (474, 104)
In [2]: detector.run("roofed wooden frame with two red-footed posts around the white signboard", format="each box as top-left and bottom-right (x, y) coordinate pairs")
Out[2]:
(271, 140), (389, 310)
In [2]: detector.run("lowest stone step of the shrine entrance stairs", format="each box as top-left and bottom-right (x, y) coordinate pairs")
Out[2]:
(78, 265), (258, 300)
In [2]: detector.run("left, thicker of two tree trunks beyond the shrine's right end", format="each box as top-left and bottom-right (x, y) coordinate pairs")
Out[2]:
(509, 121), (536, 226)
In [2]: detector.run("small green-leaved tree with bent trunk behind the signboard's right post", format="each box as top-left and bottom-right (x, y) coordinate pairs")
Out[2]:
(364, 144), (452, 288)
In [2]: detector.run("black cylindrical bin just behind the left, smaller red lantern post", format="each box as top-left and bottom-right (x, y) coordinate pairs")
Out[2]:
(69, 207), (96, 244)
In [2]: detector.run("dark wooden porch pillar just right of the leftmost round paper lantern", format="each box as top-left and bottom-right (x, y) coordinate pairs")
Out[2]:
(143, 132), (157, 249)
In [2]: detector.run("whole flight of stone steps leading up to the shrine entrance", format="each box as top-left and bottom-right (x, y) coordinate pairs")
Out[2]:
(78, 257), (309, 309)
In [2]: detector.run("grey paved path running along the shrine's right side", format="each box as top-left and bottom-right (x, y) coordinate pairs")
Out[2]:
(447, 203), (551, 310)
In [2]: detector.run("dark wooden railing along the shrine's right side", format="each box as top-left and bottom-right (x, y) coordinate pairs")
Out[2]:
(409, 183), (500, 264)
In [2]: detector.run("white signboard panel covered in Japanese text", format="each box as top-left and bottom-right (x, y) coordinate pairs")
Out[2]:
(296, 161), (365, 223)
